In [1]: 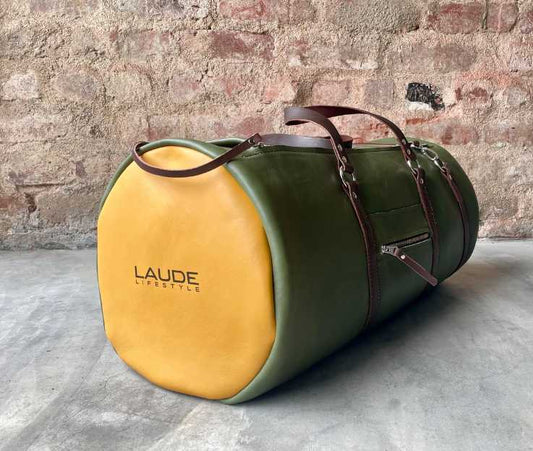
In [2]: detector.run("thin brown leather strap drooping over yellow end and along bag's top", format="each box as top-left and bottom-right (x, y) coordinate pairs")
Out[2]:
(131, 133), (353, 178)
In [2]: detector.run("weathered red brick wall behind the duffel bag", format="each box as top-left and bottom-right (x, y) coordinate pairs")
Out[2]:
(0, 0), (533, 248)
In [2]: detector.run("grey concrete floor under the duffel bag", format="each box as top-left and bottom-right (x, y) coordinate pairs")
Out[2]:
(0, 241), (533, 451)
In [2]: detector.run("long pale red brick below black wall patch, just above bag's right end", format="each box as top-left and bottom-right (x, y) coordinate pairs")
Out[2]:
(406, 119), (479, 145)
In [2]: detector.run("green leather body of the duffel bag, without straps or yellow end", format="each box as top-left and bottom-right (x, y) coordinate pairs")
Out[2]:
(98, 139), (479, 404)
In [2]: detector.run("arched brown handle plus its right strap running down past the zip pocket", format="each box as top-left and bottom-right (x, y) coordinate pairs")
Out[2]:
(285, 105), (439, 286)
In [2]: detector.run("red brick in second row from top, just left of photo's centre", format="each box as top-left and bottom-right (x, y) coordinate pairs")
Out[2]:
(210, 31), (274, 61)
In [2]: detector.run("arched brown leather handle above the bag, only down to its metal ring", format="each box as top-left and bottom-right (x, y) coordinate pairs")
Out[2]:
(285, 105), (416, 162)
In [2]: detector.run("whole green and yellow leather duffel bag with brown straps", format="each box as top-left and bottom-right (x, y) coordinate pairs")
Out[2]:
(98, 106), (479, 404)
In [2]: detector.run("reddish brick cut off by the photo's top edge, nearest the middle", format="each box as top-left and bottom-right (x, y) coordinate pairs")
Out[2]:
(218, 0), (289, 22)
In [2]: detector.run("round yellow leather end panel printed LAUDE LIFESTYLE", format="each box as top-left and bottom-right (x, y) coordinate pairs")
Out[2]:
(98, 146), (275, 399)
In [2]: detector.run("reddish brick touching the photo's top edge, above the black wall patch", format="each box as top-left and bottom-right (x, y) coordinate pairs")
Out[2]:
(427, 2), (484, 34)
